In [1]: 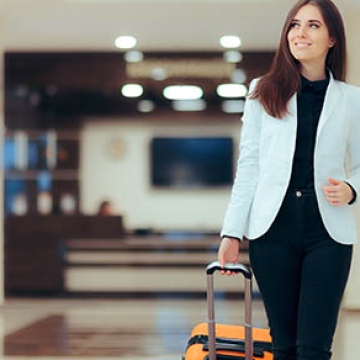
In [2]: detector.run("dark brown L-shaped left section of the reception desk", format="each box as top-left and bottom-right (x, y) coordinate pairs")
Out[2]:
(5, 215), (124, 294)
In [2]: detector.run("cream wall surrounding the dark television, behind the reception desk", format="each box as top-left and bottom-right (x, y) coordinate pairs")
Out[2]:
(80, 115), (240, 232)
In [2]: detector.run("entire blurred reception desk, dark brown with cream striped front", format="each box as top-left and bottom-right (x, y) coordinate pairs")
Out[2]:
(5, 216), (249, 297)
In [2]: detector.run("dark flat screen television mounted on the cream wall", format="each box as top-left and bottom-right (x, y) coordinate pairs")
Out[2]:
(150, 137), (234, 188)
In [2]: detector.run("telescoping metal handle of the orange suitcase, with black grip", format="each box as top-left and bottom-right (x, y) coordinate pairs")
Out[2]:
(206, 261), (253, 360)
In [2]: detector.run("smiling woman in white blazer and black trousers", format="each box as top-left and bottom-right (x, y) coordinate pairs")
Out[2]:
(218, 0), (360, 360)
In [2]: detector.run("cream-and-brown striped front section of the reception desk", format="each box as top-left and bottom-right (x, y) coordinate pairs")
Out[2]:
(64, 234), (249, 298)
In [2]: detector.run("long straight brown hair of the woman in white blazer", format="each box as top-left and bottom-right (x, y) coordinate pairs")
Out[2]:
(251, 0), (346, 119)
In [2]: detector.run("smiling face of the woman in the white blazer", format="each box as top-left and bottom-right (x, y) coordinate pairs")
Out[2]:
(287, 4), (335, 74)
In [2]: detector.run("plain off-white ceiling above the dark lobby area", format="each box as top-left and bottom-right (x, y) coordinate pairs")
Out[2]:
(1, 0), (294, 51)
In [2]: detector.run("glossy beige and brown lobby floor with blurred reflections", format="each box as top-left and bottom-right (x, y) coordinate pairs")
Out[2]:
(0, 298), (360, 360)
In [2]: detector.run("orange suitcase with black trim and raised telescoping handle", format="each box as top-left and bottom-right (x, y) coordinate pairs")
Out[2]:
(183, 261), (273, 360)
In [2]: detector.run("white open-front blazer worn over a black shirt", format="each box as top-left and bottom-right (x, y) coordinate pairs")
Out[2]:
(220, 74), (360, 244)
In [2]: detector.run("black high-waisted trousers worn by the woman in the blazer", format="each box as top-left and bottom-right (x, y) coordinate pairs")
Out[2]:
(249, 190), (352, 360)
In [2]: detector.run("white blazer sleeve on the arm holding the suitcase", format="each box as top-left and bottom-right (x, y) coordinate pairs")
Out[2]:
(220, 80), (262, 240)
